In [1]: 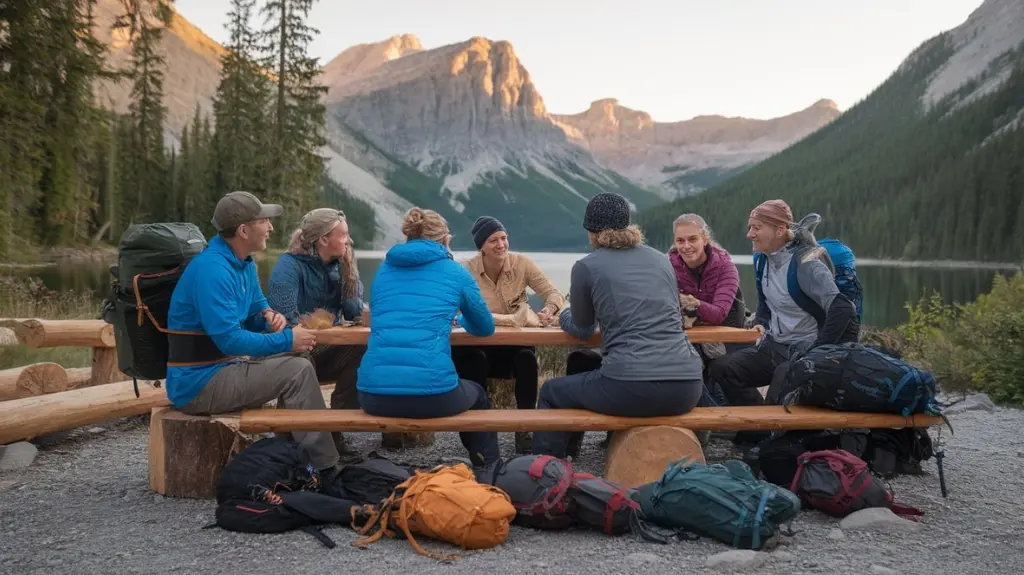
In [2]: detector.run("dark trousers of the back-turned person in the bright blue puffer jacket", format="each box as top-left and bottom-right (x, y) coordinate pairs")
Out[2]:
(359, 380), (501, 465)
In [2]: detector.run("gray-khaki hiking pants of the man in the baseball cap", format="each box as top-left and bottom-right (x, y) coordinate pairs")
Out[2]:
(181, 355), (338, 470)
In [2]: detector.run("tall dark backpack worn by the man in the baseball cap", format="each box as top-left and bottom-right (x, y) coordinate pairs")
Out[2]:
(102, 223), (207, 397)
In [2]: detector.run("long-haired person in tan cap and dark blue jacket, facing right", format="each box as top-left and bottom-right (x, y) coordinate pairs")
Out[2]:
(266, 208), (367, 456)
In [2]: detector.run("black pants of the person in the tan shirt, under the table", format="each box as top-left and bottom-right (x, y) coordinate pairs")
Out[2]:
(452, 346), (538, 409)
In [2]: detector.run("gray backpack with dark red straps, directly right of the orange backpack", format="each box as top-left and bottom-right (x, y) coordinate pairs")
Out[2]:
(494, 455), (573, 529)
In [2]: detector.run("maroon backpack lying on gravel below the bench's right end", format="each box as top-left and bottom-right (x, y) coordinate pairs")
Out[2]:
(790, 449), (924, 521)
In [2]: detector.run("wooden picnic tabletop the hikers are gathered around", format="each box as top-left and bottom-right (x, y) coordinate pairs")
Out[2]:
(316, 325), (758, 346)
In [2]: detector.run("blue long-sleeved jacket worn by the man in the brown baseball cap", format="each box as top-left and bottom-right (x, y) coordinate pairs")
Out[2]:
(166, 235), (292, 407)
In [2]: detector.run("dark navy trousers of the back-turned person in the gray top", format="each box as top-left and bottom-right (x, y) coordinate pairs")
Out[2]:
(534, 351), (703, 457)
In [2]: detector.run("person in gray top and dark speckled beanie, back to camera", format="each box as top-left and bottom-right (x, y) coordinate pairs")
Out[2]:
(534, 193), (703, 457)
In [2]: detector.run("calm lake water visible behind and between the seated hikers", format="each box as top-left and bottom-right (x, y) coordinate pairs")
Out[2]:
(6, 251), (1015, 327)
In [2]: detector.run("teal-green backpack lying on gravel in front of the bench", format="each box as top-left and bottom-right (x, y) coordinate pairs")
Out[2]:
(633, 457), (800, 549)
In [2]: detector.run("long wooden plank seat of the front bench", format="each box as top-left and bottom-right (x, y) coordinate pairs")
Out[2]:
(239, 405), (942, 433)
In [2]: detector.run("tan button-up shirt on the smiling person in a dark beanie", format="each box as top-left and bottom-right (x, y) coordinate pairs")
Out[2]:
(462, 252), (565, 315)
